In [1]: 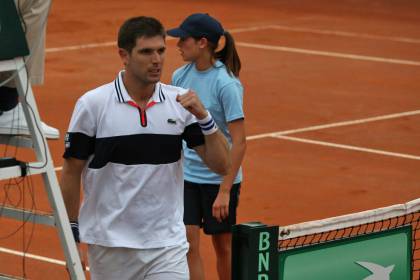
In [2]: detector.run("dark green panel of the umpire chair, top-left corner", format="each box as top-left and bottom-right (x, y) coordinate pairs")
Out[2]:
(0, 0), (29, 60)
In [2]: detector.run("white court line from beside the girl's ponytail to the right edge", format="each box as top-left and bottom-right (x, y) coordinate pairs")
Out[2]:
(236, 42), (420, 66)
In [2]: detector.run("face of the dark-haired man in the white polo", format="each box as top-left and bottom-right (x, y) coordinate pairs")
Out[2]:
(120, 36), (166, 85)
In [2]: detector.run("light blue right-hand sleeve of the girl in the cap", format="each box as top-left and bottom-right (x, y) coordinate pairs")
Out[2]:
(220, 82), (245, 122)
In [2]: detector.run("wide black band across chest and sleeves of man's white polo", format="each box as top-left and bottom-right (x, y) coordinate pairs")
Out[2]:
(63, 123), (204, 169)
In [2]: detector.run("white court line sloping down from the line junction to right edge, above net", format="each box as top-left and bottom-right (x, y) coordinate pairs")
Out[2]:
(274, 136), (420, 160)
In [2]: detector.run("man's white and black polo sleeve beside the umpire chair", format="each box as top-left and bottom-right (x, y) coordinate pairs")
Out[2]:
(63, 99), (96, 160)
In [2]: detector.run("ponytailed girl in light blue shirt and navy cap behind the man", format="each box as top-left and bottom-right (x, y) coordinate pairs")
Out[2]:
(167, 14), (246, 280)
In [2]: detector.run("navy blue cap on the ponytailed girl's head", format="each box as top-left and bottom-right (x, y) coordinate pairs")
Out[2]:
(167, 14), (225, 44)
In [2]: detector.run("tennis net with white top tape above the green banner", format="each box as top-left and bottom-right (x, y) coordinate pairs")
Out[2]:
(278, 199), (420, 280)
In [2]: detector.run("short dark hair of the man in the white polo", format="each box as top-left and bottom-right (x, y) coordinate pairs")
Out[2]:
(118, 16), (166, 53)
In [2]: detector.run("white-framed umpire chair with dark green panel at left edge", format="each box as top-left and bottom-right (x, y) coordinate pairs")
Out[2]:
(0, 0), (85, 280)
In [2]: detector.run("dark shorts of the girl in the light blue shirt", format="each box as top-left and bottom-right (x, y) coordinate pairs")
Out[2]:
(184, 181), (241, 234)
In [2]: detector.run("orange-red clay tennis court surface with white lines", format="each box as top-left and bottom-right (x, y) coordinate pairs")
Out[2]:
(0, 0), (420, 279)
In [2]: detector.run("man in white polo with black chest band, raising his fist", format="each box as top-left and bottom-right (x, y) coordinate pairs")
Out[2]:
(61, 17), (230, 280)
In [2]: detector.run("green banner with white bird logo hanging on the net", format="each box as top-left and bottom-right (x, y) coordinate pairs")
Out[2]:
(278, 226), (412, 280)
